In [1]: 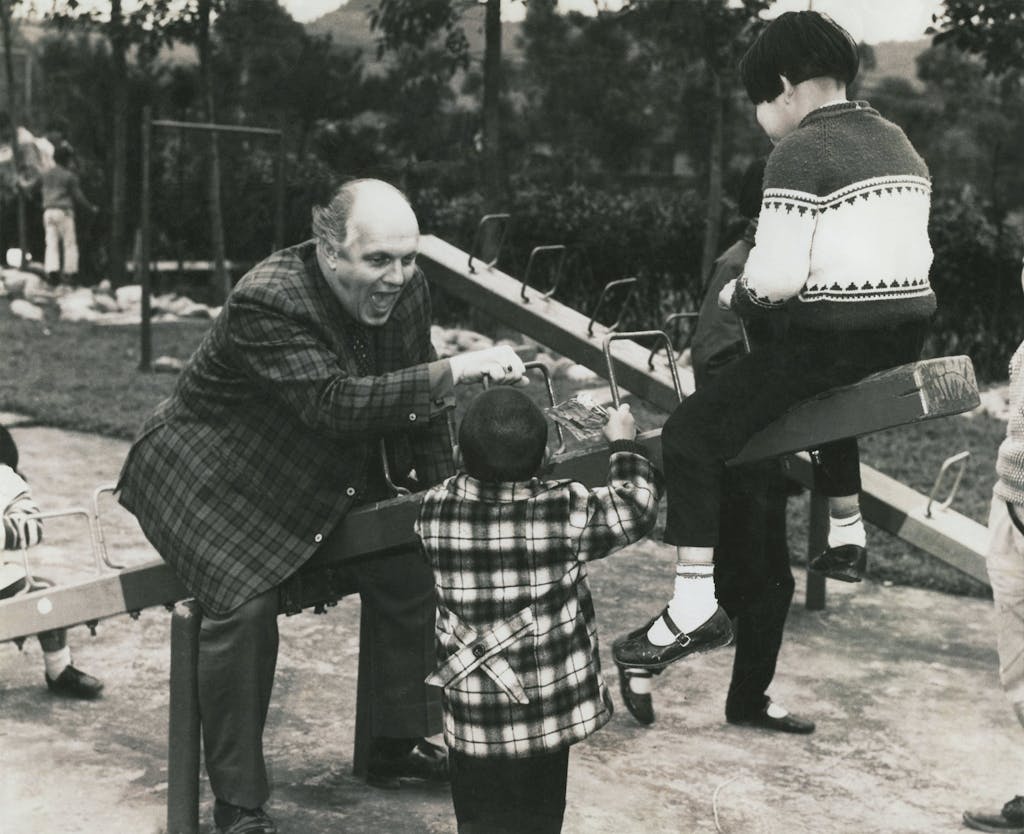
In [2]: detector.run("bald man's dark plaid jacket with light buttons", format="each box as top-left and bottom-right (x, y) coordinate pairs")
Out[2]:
(119, 241), (454, 614)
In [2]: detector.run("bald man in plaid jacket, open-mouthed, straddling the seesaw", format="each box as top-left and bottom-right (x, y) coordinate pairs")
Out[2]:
(119, 179), (523, 834)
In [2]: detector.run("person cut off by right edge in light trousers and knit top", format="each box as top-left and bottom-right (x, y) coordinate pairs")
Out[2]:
(964, 258), (1024, 834)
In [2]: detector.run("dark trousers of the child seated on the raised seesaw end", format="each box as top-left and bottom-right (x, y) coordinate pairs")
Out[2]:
(662, 322), (925, 547)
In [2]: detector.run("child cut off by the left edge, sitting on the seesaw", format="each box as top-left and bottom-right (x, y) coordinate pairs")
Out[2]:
(0, 426), (103, 700)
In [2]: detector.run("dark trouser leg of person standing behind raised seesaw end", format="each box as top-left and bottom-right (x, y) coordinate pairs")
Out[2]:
(715, 460), (794, 720)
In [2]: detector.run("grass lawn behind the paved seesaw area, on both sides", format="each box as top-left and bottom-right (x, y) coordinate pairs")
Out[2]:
(0, 303), (1006, 595)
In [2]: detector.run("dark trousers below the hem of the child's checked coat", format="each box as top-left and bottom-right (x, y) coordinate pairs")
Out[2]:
(449, 748), (569, 834)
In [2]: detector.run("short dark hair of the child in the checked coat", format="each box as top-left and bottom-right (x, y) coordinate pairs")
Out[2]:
(459, 386), (548, 484)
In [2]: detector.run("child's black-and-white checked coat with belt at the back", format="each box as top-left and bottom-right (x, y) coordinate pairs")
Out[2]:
(416, 441), (660, 758)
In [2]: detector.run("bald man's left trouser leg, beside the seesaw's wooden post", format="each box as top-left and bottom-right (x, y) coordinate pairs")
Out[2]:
(193, 588), (278, 808)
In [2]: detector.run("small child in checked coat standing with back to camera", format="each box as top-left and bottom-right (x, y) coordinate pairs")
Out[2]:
(416, 387), (660, 834)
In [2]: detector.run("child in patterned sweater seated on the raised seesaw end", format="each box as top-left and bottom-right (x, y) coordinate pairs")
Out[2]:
(614, 11), (935, 672)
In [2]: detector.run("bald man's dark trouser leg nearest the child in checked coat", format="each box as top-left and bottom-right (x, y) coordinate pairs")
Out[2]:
(352, 548), (441, 752)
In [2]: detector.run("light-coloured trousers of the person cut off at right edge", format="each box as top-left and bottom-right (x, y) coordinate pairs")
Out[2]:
(986, 495), (1024, 723)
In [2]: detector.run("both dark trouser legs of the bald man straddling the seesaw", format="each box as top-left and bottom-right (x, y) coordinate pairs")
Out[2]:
(199, 537), (441, 807)
